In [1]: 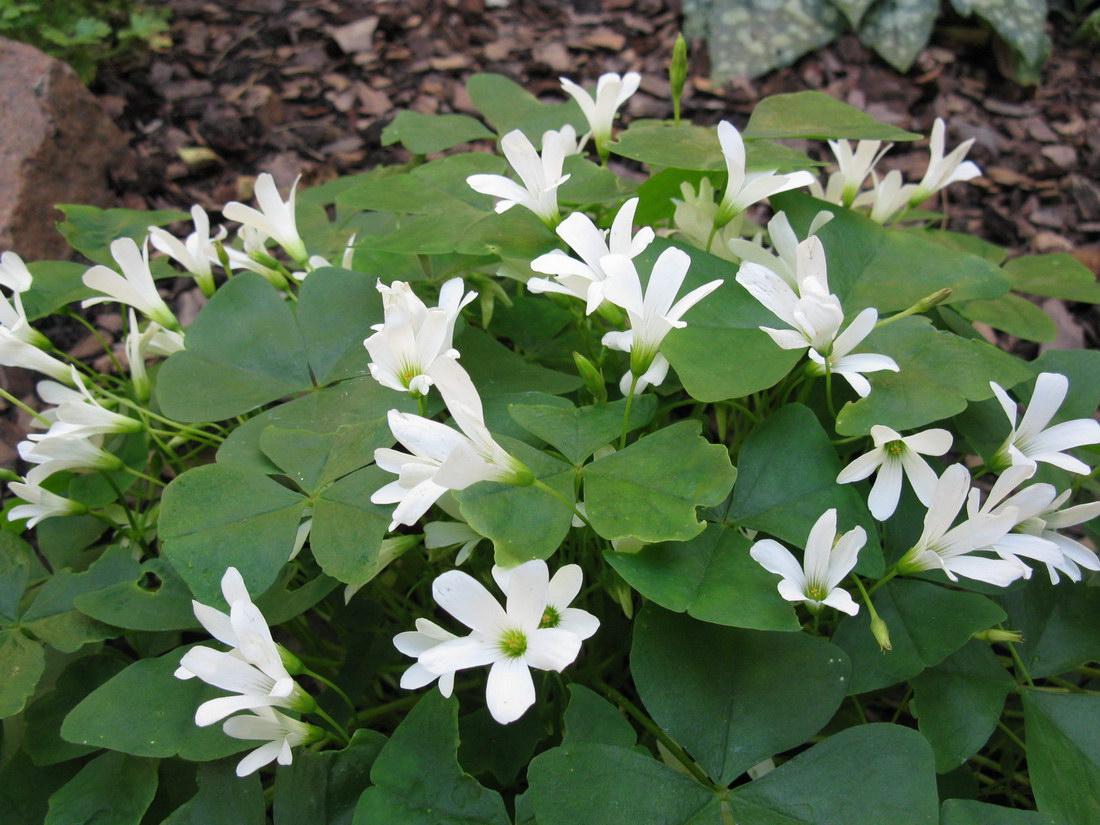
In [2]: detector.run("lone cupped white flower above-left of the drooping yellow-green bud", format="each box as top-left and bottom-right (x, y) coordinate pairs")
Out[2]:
(749, 509), (867, 616)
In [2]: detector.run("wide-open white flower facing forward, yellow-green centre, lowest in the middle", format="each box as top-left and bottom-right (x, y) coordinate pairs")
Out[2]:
(419, 560), (594, 725)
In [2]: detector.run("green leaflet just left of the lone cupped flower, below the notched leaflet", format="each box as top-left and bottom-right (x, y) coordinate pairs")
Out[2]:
(604, 525), (801, 630)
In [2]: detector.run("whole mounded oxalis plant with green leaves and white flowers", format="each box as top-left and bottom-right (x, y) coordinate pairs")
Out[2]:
(0, 53), (1100, 825)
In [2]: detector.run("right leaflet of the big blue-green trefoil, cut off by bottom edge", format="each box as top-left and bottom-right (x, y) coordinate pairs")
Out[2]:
(729, 724), (939, 825)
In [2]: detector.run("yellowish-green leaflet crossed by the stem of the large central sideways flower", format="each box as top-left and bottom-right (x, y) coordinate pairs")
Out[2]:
(454, 438), (573, 567)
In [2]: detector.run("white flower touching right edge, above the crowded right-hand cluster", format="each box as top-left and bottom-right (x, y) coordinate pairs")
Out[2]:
(989, 373), (1100, 475)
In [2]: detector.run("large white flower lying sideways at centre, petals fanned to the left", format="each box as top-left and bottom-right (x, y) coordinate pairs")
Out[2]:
(371, 359), (531, 530)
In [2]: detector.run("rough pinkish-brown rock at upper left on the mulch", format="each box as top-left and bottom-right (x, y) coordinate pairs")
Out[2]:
(0, 37), (132, 261)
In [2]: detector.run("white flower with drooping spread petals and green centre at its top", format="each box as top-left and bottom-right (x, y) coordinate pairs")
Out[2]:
(836, 424), (952, 521)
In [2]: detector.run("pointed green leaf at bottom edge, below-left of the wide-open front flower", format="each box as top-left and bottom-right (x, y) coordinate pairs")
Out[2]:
(353, 690), (510, 825)
